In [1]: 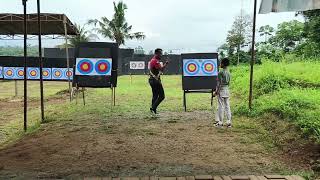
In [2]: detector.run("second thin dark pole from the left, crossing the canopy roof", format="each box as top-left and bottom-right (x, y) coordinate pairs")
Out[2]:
(37, 0), (44, 122)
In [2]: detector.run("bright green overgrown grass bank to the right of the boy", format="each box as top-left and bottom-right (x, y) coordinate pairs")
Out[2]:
(232, 60), (320, 142)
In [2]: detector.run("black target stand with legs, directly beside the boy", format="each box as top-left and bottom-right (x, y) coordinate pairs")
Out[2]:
(181, 53), (219, 111)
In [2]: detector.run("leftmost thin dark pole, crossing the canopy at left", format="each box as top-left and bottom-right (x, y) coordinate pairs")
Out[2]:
(22, 0), (28, 131)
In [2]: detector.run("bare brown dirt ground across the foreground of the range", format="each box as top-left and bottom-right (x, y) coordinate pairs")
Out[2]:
(0, 105), (316, 178)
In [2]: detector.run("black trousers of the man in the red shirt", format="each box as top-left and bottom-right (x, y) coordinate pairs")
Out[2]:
(149, 78), (165, 110)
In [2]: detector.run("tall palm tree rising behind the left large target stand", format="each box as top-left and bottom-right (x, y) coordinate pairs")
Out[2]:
(88, 1), (145, 46)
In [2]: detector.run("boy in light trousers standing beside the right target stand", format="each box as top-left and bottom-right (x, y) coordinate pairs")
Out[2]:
(215, 58), (232, 128)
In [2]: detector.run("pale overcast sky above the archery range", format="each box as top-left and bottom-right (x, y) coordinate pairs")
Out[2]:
(0, 0), (301, 52)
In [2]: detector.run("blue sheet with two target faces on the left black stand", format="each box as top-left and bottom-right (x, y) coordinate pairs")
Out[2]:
(75, 58), (112, 76)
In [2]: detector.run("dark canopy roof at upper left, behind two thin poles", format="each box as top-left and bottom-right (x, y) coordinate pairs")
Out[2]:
(0, 13), (78, 35)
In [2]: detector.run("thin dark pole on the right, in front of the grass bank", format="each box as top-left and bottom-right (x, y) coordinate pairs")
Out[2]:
(249, 0), (257, 109)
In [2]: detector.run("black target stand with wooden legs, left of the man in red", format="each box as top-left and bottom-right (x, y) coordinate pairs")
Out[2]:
(72, 42), (119, 107)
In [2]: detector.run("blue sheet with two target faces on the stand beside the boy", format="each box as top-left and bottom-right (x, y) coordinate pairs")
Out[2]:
(183, 59), (218, 76)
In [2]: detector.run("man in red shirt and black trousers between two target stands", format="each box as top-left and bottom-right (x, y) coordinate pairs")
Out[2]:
(149, 48), (169, 114)
